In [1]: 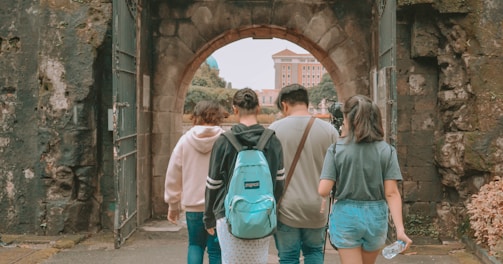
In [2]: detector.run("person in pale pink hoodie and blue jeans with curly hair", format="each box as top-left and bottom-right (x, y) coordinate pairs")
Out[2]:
(164, 101), (229, 264)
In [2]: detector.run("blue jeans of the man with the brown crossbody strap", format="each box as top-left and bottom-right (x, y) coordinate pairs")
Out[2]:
(274, 221), (326, 264)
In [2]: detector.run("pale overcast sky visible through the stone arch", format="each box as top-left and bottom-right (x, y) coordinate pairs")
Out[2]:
(212, 38), (309, 90)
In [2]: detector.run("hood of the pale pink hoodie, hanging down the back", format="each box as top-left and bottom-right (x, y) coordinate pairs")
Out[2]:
(185, 126), (224, 154)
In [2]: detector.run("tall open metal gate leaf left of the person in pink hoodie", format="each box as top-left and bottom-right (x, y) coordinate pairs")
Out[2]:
(112, 0), (137, 248)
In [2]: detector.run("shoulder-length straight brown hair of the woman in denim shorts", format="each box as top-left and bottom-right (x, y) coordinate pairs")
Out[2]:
(342, 95), (384, 143)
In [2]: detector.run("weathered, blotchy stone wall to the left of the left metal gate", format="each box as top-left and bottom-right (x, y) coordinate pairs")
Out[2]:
(0, 0), (111, 234)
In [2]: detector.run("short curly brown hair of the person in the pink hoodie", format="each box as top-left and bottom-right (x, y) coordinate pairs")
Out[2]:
(190, 101), (229, 126)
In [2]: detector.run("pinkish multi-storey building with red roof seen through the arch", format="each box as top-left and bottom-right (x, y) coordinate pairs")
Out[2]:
(272, 49), (327, 89)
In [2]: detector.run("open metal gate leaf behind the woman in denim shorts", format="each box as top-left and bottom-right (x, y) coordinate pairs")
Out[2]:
(374, 0), (397, 146)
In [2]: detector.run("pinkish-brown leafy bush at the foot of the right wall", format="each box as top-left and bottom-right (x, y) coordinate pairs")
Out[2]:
(466, 177), (503, 254)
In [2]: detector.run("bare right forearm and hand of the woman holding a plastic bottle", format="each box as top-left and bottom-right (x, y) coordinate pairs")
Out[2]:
(384, 180), (412, 249)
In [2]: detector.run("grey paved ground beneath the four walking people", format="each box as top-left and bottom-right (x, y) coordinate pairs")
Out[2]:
(0, 221), (500, 264)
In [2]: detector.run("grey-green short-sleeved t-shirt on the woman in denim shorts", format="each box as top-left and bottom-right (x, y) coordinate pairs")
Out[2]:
(320, 139), (402, 201)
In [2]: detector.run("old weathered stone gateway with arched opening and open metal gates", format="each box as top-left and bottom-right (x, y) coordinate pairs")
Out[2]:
(0, 0), (503, 250)
